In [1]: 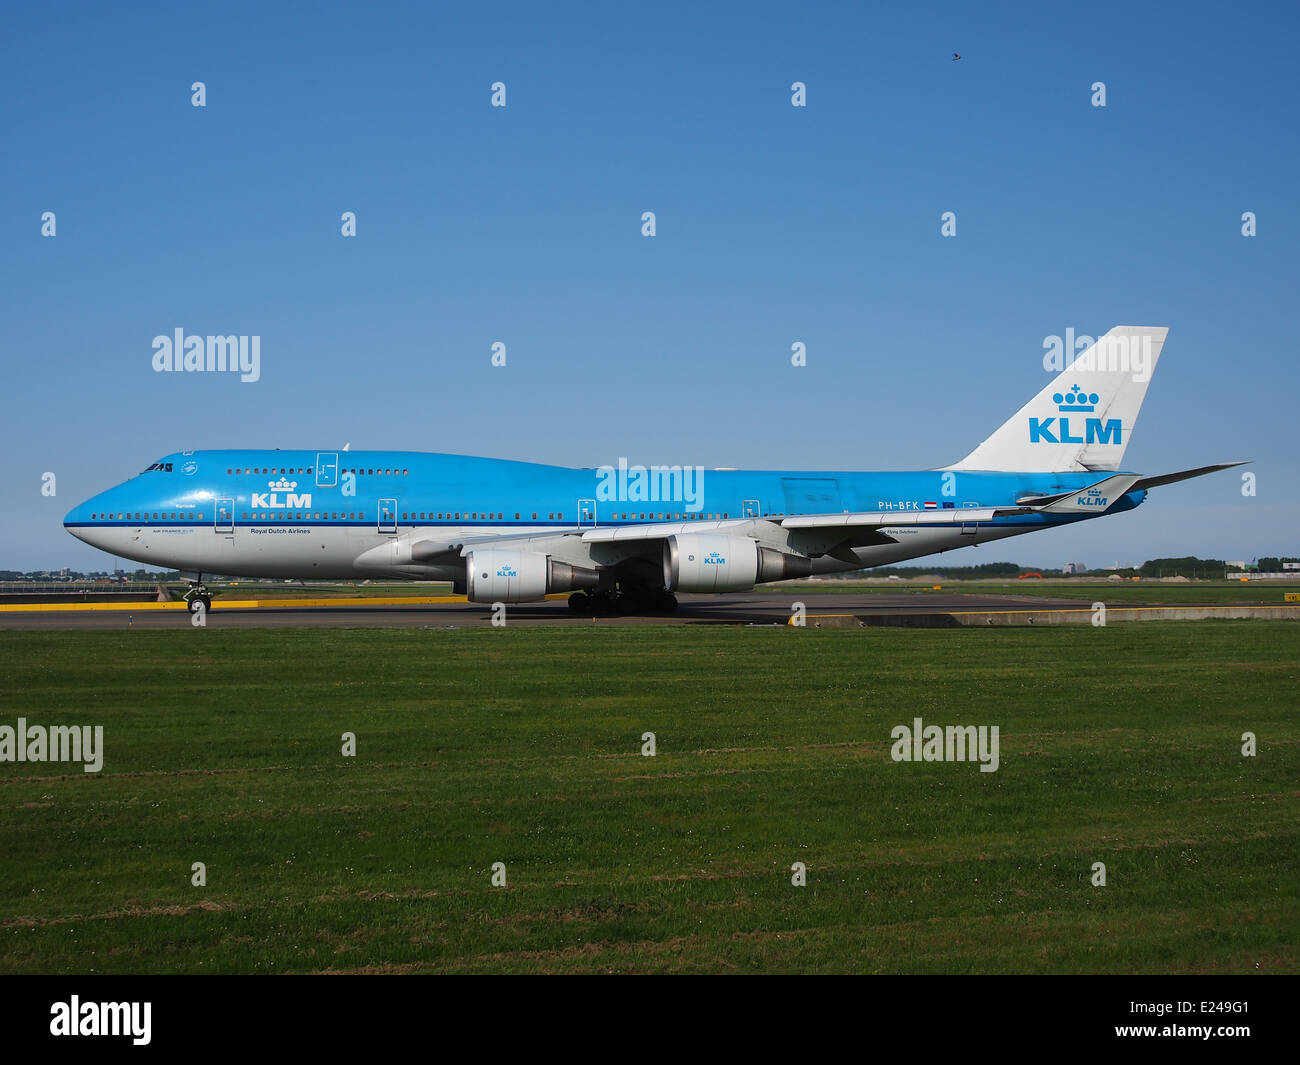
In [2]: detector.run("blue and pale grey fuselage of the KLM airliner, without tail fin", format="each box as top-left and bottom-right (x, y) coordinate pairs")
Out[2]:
(64, 450), (1145, 579)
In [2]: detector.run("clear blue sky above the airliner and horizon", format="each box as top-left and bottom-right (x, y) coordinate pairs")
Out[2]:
(0, 4), (1300, 568)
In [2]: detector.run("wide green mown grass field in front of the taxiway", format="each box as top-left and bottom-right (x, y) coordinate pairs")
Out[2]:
(0, 622), (1300, 973)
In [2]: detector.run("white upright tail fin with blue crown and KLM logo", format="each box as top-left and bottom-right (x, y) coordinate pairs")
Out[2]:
(943, 325), (1169, 473)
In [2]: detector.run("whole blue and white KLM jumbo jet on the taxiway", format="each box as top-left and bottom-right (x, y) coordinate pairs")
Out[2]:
(64, 326), (1242, 615)
